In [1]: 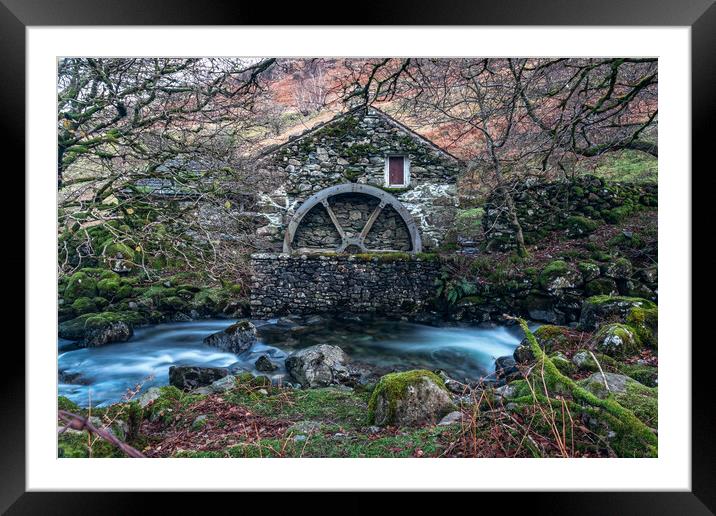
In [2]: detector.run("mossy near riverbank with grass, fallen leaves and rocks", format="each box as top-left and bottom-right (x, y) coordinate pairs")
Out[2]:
(58, 297), (658, 457)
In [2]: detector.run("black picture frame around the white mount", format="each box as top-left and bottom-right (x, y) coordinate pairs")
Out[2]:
(0, 0), (716, 515)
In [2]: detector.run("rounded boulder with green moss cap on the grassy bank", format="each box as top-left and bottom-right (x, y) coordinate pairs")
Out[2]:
(368, 370), (455, 426)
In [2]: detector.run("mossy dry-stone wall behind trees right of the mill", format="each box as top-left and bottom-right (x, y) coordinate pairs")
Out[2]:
(482, 176), (658, 250)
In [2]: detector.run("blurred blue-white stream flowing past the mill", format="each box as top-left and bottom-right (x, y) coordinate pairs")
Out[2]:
(58, 319), (522, 406)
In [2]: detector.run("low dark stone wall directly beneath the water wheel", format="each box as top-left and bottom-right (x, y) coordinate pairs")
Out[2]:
(251, 254), (440, 318)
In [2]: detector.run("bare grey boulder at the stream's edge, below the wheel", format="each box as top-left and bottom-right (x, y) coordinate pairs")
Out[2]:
(286, 344), (351, 387)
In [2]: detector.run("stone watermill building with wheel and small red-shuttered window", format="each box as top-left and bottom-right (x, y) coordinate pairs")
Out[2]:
(251, 107), (461, 317)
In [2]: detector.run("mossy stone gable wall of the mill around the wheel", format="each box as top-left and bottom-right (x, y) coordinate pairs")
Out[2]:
(257, 110), (460, 251)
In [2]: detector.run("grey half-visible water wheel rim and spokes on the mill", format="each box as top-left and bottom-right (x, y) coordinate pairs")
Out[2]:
(283, 183), (422, 253)
